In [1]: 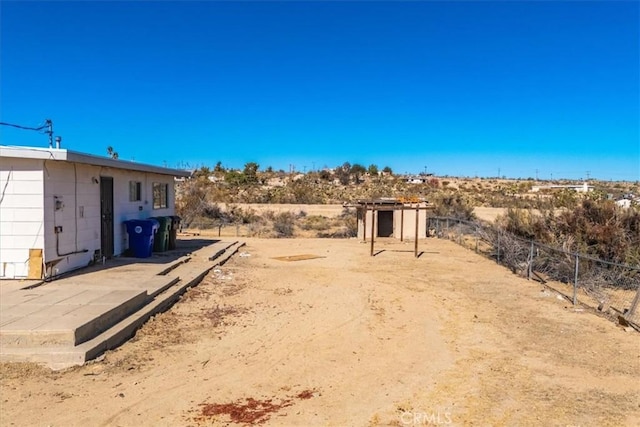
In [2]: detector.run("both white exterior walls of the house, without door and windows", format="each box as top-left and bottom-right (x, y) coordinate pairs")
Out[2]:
(0, 157), (175, 278)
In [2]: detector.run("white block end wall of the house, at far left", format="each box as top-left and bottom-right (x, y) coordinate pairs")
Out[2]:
(0, 159), (44, 278)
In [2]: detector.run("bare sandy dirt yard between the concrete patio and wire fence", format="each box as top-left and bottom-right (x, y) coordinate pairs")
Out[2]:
(0, 239), (640, 426)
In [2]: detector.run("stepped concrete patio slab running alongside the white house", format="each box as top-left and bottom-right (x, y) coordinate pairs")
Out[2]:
(0, 238), (244, 369)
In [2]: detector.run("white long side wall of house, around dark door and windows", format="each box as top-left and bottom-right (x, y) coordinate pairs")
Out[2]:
(44, 161), (175, 275)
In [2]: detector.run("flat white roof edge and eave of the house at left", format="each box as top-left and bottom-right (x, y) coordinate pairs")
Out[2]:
(0, 145), (191, 177)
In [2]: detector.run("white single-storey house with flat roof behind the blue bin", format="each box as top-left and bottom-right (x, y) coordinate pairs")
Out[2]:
(0, 146), (190, 279)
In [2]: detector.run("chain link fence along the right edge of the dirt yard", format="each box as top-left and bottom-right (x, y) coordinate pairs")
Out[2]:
(428, 217), (640, 329)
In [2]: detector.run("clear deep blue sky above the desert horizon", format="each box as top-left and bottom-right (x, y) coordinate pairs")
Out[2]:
(0, 1), (640, 181)
